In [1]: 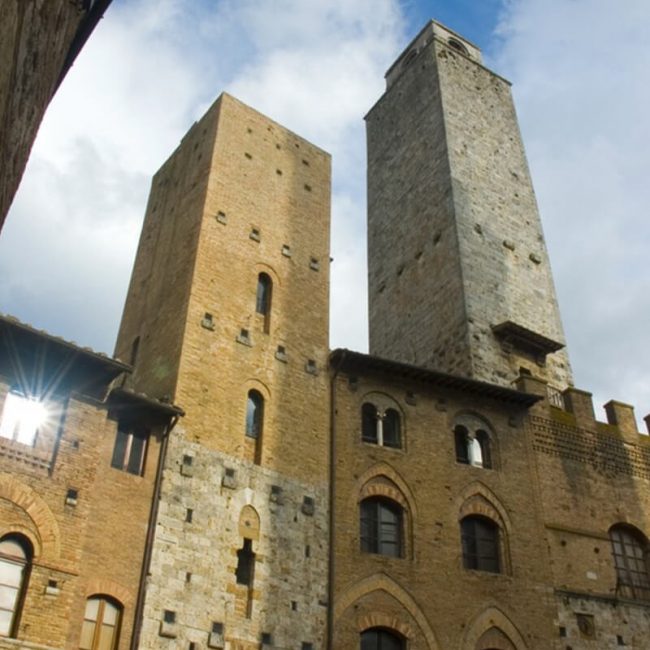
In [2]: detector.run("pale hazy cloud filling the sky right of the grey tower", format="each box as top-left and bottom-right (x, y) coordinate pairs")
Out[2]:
(494, 0), (650, 417)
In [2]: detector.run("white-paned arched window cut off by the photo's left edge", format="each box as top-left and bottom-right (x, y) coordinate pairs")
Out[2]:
(0, 535), (33, 637)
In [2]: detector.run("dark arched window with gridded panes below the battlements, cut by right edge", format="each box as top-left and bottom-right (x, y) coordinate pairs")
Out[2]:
(609, 524), (650, 600)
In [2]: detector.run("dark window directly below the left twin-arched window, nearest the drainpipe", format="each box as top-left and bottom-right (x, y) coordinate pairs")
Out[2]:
(360, 497), (403, 557)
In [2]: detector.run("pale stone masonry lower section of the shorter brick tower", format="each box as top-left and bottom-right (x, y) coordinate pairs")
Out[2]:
(140, 428), (328, 650)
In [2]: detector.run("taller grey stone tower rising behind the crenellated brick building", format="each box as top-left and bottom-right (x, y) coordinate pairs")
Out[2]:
(366, 22), (572, 389)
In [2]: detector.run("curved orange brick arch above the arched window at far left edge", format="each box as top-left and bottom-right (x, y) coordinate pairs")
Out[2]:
(0, 474), (61, 561)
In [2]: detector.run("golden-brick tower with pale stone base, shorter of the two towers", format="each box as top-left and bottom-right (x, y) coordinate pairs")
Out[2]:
(116, 94), (330, 649)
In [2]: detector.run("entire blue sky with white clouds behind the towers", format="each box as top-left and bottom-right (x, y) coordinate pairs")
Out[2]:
(0, 0), (650, 422)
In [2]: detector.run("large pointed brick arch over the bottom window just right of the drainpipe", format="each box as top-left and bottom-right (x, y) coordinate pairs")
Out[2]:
(334, 573), (440, 650)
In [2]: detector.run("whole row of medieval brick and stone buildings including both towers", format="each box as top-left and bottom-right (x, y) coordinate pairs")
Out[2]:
(0, 22), (650, 650)
